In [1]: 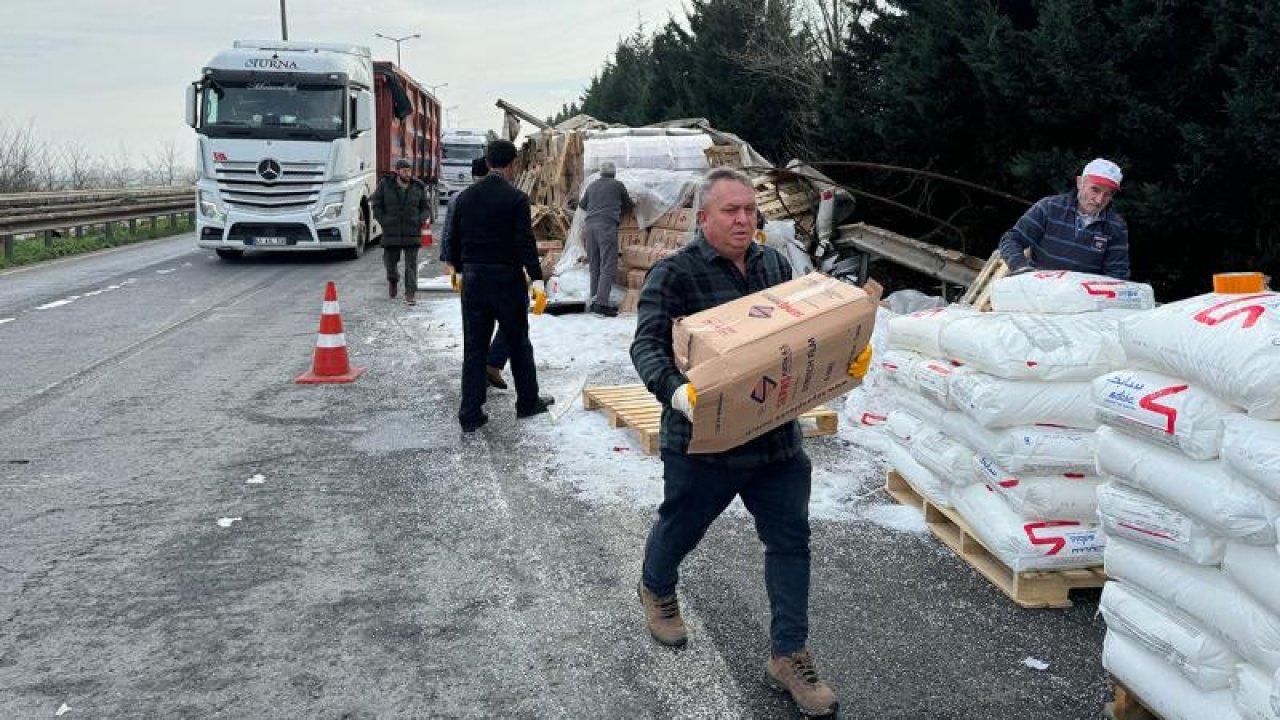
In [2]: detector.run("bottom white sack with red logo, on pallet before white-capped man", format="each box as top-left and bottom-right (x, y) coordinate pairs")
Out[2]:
(951, 484), (1106, 573)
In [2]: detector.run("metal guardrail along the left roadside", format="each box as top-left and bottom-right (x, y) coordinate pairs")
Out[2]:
(0, 187), (196, 258)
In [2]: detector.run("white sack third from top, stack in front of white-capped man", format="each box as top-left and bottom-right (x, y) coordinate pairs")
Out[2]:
(947, 372), (1098, 430)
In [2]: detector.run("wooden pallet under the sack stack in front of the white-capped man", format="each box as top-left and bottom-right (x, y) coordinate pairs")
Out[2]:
(884, 470), (1107, 607)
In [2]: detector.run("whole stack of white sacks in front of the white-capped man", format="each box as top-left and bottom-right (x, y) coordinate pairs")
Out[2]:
(881, 273), (1152, 571)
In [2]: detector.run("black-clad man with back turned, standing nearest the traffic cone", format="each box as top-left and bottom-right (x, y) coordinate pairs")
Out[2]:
(449, 140), (554, 433)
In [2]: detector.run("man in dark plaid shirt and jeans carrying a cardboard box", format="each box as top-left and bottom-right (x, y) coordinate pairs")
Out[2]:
(631, 168), (837, 715)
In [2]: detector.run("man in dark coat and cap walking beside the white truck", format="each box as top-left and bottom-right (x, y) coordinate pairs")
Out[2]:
(372, 158), (431, 305)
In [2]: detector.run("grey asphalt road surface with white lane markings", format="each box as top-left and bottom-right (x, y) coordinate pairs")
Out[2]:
(0, 236), (1106, 720)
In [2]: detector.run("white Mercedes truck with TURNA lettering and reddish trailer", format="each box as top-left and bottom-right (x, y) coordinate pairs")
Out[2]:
(187, 40), (440, 259)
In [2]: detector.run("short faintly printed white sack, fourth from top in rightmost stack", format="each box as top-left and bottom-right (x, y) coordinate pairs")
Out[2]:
(1098, 480), (1223, 565)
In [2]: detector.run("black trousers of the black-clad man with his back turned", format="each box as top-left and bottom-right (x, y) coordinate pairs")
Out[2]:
(458, 264), (538, 424)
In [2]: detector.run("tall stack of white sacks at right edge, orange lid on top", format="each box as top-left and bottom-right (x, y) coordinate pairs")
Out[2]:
(1092, 288), (1280, 719)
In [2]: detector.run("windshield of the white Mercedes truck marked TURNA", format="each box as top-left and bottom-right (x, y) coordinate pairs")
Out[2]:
(201, 79), (347, 140)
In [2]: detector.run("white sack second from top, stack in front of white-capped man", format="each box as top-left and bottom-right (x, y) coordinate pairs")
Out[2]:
(940, 313), (1125, 380)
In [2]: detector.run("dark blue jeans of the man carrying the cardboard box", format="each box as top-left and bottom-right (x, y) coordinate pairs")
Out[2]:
(643, 451), (813, 655)
